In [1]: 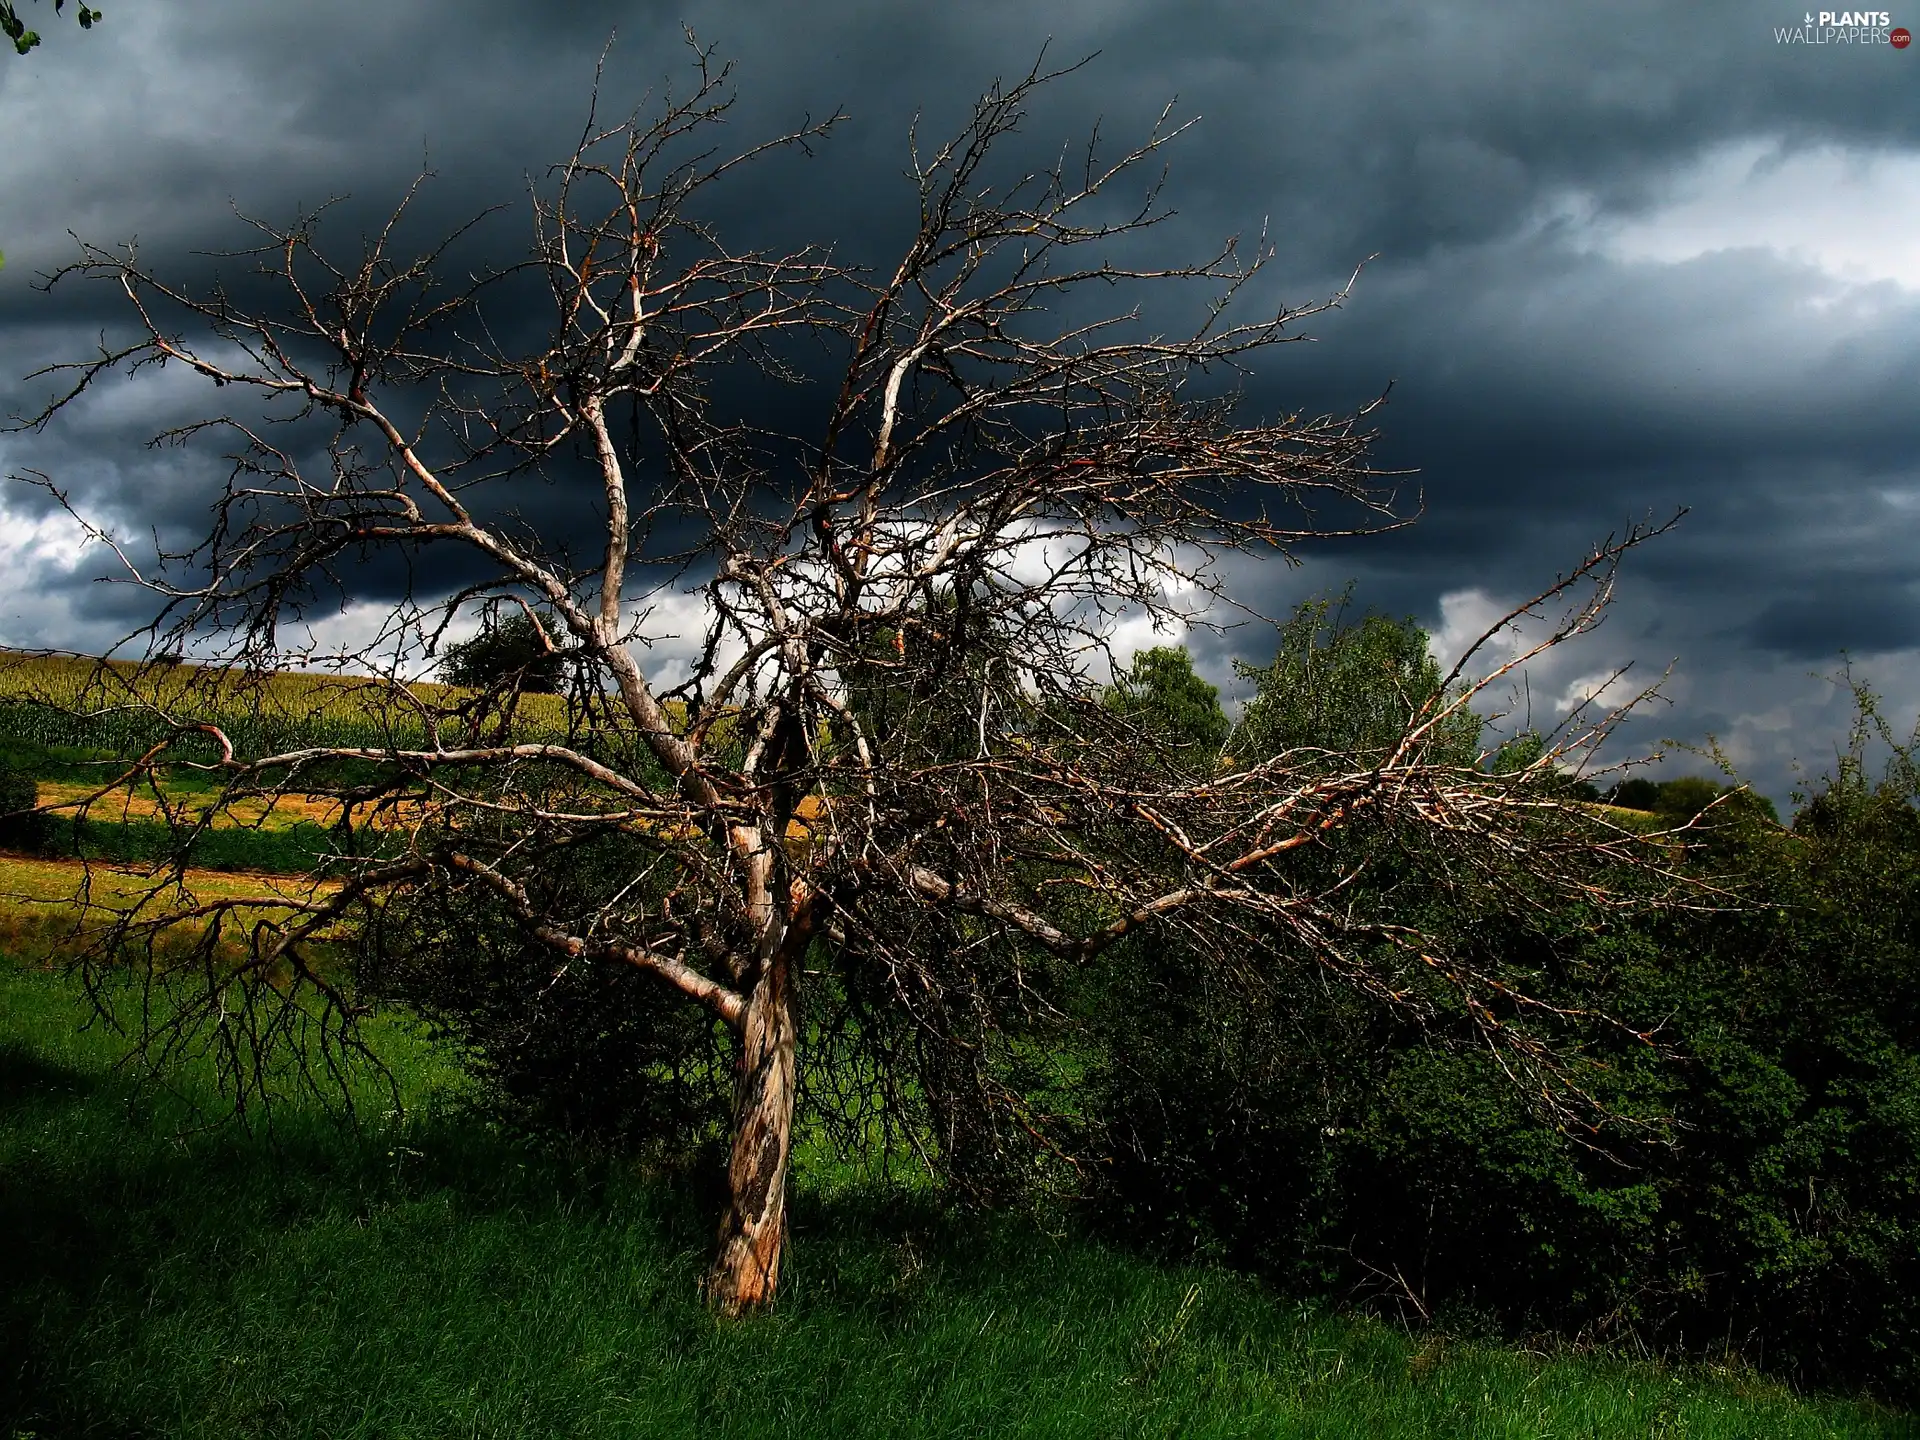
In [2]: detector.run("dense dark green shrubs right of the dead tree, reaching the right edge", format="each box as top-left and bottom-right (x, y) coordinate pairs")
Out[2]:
(1096, 660), (1920, 1400)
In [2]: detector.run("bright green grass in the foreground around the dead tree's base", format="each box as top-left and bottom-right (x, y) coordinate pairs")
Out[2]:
(0, 966), (1914, 1440)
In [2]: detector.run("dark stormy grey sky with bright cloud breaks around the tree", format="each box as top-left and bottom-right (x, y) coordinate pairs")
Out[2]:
(0, 0), (1920, 799)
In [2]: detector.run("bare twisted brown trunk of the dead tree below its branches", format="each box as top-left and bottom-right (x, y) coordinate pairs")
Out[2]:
(707, 947), (795, 1315)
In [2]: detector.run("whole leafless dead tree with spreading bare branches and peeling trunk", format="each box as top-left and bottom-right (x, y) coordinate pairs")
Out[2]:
(7, 50), (1689, 1311)
